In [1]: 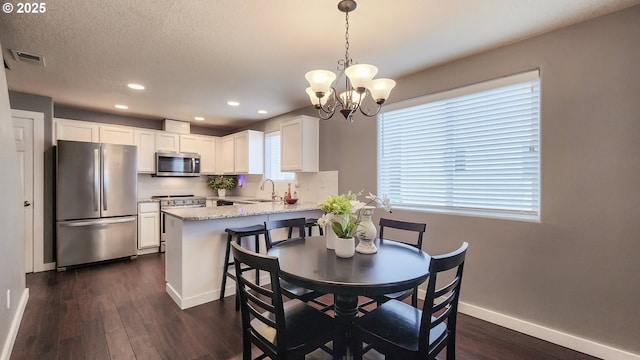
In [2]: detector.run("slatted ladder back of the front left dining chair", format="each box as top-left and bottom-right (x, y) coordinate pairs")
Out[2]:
(231, 243), (287, 358)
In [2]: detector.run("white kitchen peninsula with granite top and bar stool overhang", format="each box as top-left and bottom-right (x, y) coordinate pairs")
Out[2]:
(163, 202), (323, 309)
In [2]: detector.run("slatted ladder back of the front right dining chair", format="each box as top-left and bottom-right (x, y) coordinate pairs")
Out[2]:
(419, 242), (468, 354)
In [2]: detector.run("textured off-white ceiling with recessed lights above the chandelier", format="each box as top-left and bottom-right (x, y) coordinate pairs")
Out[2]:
(0, 0), (640, 128)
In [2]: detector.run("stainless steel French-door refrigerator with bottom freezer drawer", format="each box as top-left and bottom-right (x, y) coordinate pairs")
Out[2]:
(56, 140), (138, 271)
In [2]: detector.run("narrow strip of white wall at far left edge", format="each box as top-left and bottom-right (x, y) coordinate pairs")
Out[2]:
(0, 41), (28, 360)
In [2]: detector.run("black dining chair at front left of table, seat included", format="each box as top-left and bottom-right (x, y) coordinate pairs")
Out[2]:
(231, 243), (335, 360)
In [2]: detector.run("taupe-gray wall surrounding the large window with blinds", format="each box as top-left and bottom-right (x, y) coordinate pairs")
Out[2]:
(320, 6), (640, 354)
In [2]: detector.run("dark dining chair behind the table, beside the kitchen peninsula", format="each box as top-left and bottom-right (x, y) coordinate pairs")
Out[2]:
(264, 218), (333, 311)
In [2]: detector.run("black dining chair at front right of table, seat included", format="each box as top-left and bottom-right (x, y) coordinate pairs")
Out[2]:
(352, 242), (468, 360)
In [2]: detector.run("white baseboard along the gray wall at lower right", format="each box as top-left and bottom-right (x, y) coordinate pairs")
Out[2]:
(458, 300), (640, 360)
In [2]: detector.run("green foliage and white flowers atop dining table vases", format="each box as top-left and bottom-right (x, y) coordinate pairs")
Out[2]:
(318, 191), (391, 239)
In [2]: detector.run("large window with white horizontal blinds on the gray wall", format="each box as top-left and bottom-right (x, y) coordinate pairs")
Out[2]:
(378, 70), (540, 219)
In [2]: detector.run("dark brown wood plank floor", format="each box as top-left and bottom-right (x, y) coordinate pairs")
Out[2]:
(11, 254), (595, 360)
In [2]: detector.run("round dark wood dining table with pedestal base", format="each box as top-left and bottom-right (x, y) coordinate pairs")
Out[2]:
(267, 236), (431, 357)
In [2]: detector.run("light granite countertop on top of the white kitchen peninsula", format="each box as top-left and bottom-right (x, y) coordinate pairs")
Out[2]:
(162, 202), (318, 221)
